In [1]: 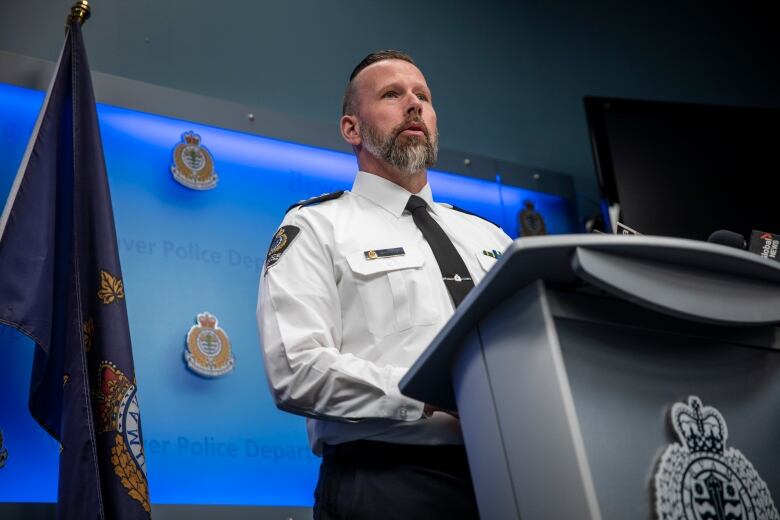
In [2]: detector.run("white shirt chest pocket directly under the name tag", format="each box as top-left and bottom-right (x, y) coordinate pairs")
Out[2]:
(346, 246), (436, 337)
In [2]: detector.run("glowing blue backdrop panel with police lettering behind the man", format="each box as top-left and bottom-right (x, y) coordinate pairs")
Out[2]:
(0, 84), (578, 506)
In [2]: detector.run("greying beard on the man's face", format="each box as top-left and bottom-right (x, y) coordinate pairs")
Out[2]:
(360, 121), (439, 176)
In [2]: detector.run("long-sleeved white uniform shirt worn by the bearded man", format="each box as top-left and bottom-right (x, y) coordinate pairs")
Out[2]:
(258, 172), (511, 454)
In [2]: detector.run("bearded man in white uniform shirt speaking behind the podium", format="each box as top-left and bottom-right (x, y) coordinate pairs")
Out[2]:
(258, 51), (511, 520)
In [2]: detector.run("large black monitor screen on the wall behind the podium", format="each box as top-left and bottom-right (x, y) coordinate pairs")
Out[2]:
(585, 97), (780, 240)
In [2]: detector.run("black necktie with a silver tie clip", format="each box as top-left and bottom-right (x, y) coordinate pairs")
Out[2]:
(406, 195), (474, 307)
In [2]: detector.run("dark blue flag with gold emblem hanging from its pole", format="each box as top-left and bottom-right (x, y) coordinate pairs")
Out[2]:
(0, 20), (150, 520)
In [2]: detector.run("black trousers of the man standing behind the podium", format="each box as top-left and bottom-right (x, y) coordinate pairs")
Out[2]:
(314, 441), (479, 520)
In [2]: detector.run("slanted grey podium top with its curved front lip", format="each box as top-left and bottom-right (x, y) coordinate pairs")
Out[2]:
(399, 234), (780, 404)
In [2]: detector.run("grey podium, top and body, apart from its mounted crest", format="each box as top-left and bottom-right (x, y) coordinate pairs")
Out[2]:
(400, 235), (780, 520)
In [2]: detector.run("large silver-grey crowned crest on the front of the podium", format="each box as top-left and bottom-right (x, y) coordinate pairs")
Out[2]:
(655, 396), (780, 520)
